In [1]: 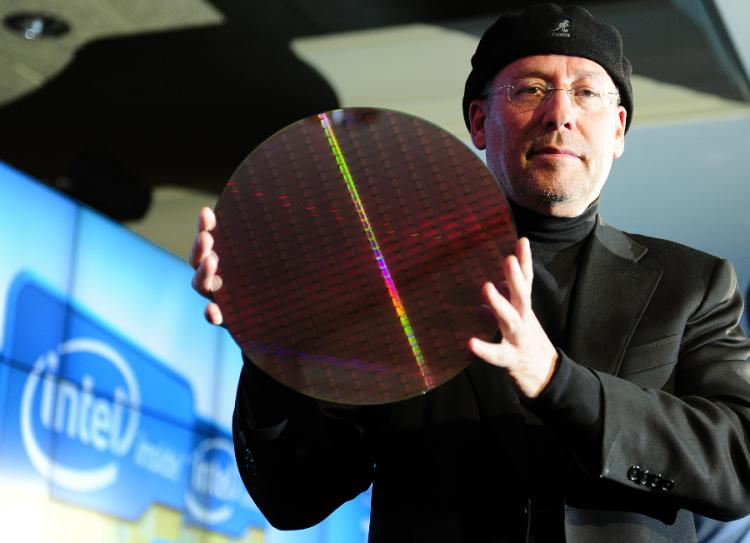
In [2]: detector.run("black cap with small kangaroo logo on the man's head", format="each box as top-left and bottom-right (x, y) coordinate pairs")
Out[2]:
(463, 4), (633, 132)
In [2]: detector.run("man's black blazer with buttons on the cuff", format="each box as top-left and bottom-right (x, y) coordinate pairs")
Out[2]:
(234, 219), (750, 543)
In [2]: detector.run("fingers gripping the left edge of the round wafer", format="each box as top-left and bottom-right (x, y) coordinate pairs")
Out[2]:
(189, 207), (224, 326)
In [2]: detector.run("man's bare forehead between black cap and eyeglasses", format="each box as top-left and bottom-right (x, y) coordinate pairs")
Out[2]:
(495, 55), (614, 86)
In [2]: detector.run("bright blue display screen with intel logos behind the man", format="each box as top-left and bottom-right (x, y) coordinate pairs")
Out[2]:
(0, 163), (369, 543)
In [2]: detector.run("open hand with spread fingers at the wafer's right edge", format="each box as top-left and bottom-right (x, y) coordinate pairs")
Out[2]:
(469, 238), (557, 398)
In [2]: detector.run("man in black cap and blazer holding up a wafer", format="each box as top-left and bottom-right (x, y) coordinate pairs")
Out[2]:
(191, 4), (750, 543)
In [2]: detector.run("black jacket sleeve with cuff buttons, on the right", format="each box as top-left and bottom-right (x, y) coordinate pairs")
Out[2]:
(535, 261), (750, 520)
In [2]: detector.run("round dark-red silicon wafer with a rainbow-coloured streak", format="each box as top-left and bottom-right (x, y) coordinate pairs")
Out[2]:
(214, 108), (516, 405)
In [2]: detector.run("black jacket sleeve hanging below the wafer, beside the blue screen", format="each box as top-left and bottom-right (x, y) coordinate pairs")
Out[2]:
(233, 359), (373, 530)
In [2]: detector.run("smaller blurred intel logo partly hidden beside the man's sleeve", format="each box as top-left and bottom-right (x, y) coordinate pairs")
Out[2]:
(185, 437), (247, 525)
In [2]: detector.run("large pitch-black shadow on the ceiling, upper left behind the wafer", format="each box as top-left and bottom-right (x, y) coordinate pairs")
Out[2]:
(0, 3), (338, 220)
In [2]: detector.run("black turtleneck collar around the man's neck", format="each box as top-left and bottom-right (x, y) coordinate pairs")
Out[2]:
(508, 198), (599, 247)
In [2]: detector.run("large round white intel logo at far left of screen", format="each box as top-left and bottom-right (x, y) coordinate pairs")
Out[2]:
(20, 338), (140, 492)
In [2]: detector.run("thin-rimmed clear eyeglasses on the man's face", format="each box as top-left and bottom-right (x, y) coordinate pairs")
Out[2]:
(485, 83), (620, 112)
